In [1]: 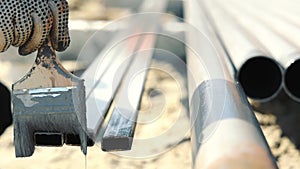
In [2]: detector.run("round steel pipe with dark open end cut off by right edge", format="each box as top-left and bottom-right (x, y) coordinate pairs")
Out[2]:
(220, 0), (300, 102)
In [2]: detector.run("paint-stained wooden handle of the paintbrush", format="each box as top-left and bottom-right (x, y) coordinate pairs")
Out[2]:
(13, 36), (81, 90)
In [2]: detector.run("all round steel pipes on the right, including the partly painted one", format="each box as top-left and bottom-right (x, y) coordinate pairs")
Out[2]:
(185, 0), (300, 169)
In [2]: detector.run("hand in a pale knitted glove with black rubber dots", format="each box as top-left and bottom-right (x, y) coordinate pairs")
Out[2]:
(0, 0), (70, 55)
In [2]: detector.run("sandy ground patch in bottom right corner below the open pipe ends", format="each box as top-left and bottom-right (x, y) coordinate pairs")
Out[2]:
(252, 92), (300, 169)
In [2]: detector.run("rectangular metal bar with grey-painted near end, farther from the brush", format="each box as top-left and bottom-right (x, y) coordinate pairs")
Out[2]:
(101, 34), (156, 151)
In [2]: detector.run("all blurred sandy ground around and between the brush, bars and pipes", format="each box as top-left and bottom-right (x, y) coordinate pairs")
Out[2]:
(0, 0), (300, 169)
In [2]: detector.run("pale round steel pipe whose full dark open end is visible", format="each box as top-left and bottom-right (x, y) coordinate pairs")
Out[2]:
(200, 1), (283, 101)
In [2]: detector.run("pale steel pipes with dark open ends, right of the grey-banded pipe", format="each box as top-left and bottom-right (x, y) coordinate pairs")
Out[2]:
(201, 0), (300, 102)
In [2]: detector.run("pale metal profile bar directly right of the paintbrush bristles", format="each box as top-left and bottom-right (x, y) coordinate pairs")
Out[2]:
(81, 0), (167, 140)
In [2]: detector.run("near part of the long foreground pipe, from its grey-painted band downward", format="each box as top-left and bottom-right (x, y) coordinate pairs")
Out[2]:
(190, 79), (276, 169)
